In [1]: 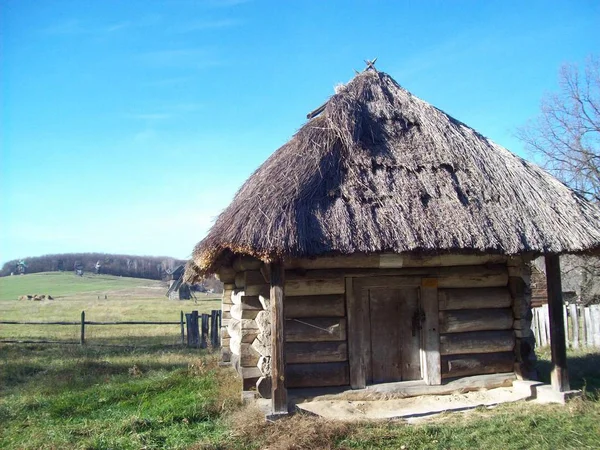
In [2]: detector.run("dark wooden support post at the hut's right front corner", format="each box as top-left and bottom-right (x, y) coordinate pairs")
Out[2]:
(545, 255), (570, 392)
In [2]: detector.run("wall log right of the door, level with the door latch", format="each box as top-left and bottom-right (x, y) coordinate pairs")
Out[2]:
(440, 308), (513, 334)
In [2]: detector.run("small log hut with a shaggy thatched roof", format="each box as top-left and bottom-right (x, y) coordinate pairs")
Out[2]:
(186, 64), (600, 415)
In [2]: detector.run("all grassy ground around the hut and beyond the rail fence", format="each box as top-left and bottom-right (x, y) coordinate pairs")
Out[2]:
(0, 274), (600, 450)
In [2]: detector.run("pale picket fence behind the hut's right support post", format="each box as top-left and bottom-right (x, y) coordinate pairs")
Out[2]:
(531, 304), (600, 348)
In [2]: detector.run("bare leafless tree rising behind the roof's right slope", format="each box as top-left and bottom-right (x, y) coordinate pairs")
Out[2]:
(517, 56), (600, 202)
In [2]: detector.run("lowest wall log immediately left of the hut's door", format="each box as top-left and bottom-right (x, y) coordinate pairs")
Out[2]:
(286, 362), (350, 388)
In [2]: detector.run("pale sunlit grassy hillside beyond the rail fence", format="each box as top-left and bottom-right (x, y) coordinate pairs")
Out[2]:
(0, 272), (220, 345)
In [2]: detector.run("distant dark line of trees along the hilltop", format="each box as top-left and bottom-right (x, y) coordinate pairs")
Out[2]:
(0, 253), (186, 280)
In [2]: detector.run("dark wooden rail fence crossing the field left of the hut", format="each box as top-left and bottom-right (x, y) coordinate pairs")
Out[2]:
(0, 310), (221, 348)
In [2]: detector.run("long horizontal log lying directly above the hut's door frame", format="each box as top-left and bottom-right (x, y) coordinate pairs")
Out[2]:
(286, 265), (508, 288)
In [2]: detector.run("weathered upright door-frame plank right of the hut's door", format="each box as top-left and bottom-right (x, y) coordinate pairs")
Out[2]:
(421, 278), (442, 385)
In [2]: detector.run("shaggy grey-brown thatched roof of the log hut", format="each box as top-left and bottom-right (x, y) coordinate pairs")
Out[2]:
(188, 70), (600, 274)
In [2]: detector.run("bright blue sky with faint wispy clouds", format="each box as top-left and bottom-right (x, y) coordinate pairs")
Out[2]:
(0, 0), (600, 261)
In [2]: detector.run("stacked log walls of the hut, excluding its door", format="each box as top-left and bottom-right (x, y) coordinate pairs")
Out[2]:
(220, 255), (533, 395)
